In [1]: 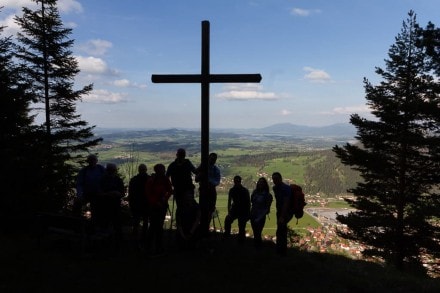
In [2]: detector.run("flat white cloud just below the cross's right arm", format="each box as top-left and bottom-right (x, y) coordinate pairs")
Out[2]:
(215, 83), (277, 101)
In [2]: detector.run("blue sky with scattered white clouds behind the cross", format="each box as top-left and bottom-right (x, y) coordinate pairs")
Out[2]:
(0, 0), (440, 128)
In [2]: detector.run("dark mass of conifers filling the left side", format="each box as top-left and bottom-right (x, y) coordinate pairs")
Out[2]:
(1, 0), (101, 226)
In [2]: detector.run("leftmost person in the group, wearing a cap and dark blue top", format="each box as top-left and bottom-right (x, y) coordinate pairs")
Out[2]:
(73, 154), (105, 222)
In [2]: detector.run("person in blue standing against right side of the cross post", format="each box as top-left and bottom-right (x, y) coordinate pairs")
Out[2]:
(198, 153), (221, 237)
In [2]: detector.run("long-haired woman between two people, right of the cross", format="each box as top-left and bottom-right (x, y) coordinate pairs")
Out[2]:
(251, 177), (278, 248)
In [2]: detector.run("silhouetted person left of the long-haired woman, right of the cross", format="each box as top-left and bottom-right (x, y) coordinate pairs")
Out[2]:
(224, 175), (251, 242)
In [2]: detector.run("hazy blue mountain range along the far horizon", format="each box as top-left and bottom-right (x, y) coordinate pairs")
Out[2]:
(95, 123), (356, 138)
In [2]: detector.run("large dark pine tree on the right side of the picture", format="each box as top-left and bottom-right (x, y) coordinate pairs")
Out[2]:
(333, 11), (440, 269)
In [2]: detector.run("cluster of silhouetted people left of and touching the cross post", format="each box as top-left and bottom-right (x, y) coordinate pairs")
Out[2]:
(73, 148), (221, 255)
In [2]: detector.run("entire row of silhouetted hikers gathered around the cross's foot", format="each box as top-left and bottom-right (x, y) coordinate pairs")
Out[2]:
(74, 148), (292, 255)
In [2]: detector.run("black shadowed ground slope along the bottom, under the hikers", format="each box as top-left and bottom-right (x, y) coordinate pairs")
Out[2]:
(0, 231), (440, 292)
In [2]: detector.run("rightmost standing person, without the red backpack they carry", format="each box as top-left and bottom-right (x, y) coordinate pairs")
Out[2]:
(272, 172), (293, 256)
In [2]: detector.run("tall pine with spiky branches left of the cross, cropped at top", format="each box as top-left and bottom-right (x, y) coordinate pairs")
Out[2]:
(15, 0), (102, 211)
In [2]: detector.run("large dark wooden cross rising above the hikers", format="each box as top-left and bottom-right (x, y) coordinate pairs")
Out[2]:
(151, 20), (261, 198)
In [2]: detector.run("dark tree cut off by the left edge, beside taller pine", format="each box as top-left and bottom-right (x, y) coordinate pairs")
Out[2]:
(0, 17), (37, 222)
